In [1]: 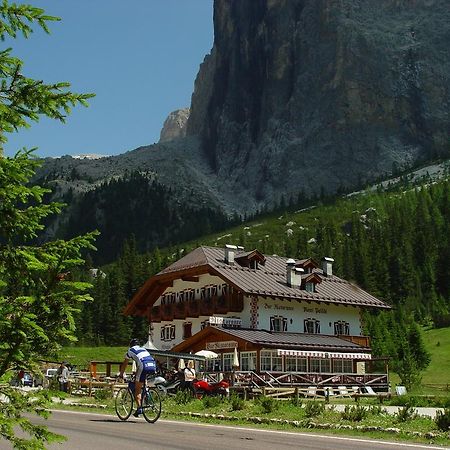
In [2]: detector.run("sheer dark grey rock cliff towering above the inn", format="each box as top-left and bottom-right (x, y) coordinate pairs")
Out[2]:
(187, 0), (450, 208)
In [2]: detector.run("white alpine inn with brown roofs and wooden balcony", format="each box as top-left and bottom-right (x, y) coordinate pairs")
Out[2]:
(125, 245), (389, 387)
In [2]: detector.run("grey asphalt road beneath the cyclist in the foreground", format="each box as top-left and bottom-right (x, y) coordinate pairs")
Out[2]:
(0, 411), (443, 450)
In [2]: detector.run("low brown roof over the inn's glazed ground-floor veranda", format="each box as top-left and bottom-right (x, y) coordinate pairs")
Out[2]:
(173, 326), (370, 352)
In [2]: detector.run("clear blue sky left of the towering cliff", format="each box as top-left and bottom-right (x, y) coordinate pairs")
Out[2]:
(0, 0), (213, 156)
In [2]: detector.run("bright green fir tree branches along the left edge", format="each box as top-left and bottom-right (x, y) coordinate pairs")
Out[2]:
(0, 0), (96, 449)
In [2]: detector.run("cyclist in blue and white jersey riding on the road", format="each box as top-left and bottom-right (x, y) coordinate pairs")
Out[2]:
(119, 339), (156, 417)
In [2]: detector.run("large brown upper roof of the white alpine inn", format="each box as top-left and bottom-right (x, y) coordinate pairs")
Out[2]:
(124, 247), (390, 315)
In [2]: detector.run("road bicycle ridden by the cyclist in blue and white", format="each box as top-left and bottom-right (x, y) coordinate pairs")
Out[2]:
(115, 374), (162, 423)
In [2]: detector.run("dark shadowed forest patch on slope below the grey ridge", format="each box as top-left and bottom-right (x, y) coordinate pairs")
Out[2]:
(47, 171), (233, 264)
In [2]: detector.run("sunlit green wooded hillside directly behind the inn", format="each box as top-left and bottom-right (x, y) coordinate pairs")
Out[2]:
(72, 174), (450, 384)
